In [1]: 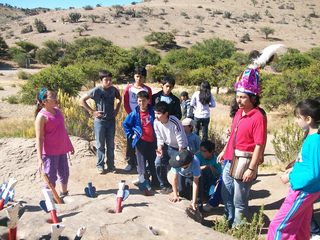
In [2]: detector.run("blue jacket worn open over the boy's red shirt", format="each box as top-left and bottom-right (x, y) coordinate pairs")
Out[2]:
(122, 104), (156, 148)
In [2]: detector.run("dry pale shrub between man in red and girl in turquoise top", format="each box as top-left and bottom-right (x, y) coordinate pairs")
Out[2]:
(272, 123), (304, 165)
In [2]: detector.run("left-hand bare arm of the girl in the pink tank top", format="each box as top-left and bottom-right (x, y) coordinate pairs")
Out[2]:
(35, 114), (46, 173)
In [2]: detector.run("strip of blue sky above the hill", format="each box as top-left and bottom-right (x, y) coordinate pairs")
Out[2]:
(0, 0), (139, 8)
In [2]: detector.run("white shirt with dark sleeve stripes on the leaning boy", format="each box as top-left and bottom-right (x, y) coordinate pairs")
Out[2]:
(154, 115), (188, 149)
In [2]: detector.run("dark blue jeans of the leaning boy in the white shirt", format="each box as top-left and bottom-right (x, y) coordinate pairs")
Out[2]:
(155, 145), (179, 188)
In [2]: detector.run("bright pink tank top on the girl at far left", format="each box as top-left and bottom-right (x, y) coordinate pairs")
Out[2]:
(39, 108), (72, 155)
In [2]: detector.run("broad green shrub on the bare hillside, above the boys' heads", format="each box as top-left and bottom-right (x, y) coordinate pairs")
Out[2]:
(144, 32), (176, 49)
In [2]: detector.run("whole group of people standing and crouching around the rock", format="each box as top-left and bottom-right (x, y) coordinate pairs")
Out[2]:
(36, 62), (320, 239)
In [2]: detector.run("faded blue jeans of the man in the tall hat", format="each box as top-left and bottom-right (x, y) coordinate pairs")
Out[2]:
(221, 161), (253, 226)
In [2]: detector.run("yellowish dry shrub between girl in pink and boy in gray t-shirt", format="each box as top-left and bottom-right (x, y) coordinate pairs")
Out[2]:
(57, 90), (94, 141)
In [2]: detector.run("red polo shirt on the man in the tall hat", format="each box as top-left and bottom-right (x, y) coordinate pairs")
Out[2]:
(223, 108), (267, 160)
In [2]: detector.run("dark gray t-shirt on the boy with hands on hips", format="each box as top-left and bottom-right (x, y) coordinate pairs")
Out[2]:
(88, 86), (120, 120)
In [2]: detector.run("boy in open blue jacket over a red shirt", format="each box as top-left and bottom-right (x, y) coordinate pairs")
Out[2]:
(123, 91), (157, 195)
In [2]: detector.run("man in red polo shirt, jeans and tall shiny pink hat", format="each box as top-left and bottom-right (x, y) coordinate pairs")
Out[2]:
(208, 68), (267, 227)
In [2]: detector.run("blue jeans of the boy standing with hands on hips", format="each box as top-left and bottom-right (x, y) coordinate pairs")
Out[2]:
(94, 119), (116, 169)
